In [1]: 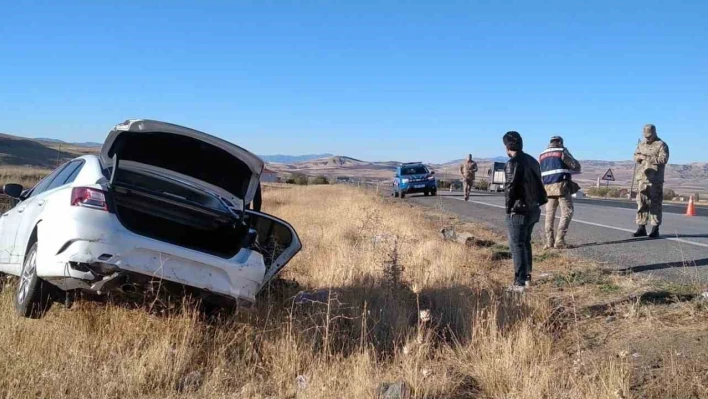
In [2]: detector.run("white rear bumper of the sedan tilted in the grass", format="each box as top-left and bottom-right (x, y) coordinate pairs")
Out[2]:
(37, 213), (265, 302)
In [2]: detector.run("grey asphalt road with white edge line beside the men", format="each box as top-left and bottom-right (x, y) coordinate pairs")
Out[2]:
(388, 191), (708, 284)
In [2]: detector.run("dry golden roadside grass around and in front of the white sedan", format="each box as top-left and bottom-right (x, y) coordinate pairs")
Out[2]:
(0, 186), (708, 399)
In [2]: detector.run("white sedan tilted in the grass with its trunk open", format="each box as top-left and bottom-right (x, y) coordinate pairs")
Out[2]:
(0, 120), (301, 317)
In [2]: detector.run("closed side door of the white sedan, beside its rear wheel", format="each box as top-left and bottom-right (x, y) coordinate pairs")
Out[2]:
(10, 164), (69, 269)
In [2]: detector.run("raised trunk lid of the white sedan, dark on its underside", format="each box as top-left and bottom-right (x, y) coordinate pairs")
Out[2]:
(100, 119), (263, 203)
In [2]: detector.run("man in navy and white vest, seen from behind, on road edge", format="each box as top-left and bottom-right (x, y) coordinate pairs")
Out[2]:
(539, 136), (580, 249)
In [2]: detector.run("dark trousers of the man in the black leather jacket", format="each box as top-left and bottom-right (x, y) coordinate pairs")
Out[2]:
(506, 207), (541, 285)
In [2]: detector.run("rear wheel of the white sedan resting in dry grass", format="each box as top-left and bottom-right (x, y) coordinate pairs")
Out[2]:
(15, 243), (50, 319)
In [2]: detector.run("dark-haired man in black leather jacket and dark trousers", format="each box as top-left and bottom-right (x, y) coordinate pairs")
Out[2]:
(503, 131), (548, 292)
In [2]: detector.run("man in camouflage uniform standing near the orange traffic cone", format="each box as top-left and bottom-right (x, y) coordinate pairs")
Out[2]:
(634, 125), (669, 238)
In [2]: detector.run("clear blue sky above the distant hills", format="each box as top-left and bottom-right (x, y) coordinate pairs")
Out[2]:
(0, 0), (708, 163)
